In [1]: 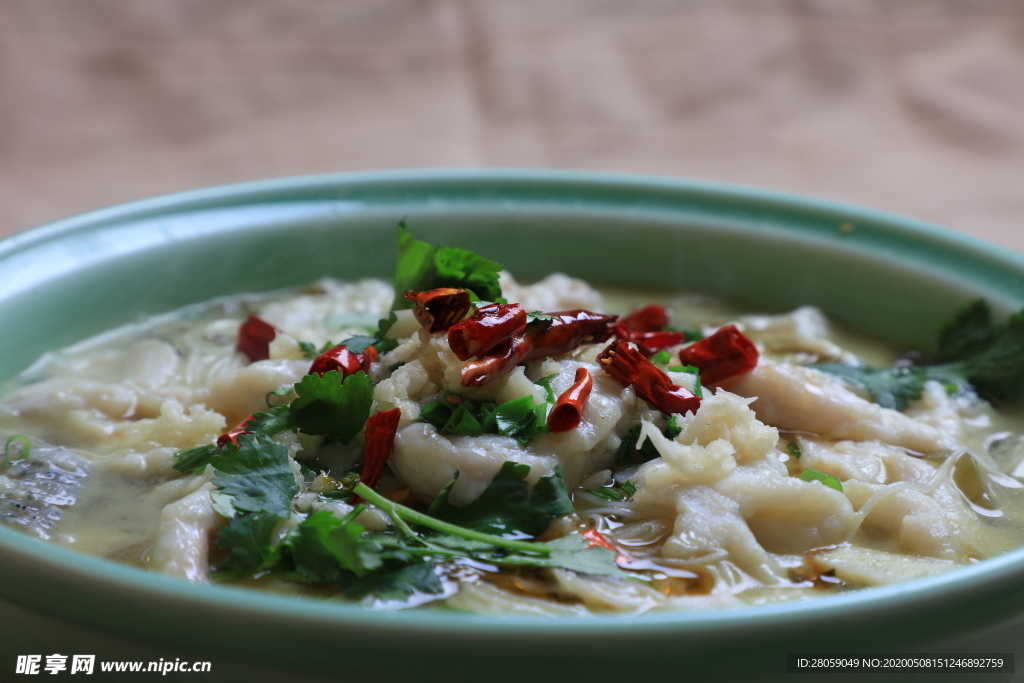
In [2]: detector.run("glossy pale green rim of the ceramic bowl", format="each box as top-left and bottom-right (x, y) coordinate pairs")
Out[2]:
(0, 163), (1024, 651)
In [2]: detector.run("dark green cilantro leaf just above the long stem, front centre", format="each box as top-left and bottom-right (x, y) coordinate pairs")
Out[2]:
(428, 461), (574, 537)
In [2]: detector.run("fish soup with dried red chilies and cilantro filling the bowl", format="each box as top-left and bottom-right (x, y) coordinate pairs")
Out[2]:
(0, 239), (1024, 614)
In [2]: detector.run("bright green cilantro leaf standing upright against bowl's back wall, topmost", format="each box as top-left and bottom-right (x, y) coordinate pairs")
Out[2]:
(391, 221), (504, 310)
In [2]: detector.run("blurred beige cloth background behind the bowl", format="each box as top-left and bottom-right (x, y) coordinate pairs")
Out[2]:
(0, 0), (1024, 251)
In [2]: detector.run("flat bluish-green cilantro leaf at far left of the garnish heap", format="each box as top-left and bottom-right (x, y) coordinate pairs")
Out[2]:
(210, 434), (299, 517)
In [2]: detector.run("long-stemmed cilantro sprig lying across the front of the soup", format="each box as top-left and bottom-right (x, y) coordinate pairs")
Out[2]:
(215, 463), (628, 600)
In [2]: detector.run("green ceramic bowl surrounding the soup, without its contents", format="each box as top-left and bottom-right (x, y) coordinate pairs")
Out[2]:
(0, 171), (1024, 681)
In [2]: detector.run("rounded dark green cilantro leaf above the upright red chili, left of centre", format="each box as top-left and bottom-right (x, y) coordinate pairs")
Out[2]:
(291, 370), (374, 443)
